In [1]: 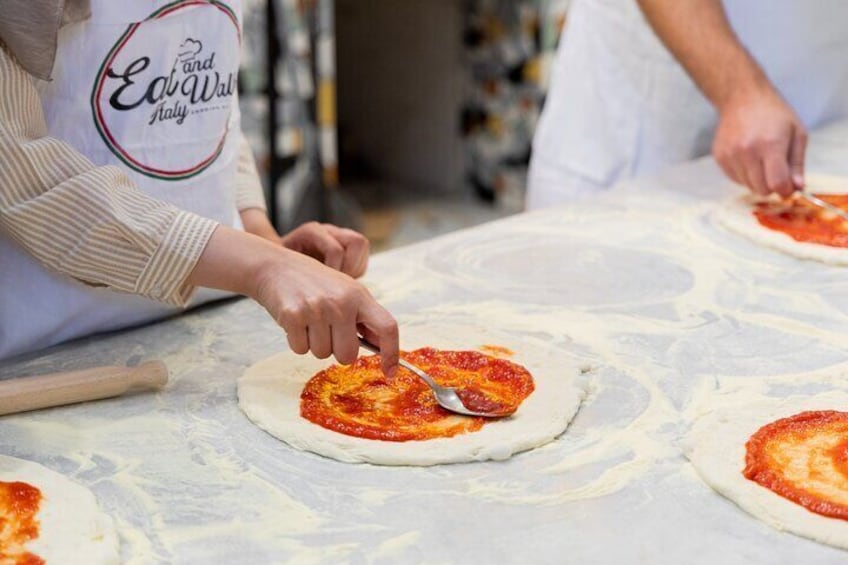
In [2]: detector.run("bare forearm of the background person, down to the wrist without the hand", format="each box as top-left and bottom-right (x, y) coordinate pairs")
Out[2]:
(638, 0), (772, 110)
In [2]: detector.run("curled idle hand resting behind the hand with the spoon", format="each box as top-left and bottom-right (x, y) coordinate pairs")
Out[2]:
(280, 222), (369, 278)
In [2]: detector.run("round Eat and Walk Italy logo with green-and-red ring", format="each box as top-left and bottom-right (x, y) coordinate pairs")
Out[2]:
(91, 0), (240, 180)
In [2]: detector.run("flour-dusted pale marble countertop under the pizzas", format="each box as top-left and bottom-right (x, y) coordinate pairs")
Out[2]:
(0, 121), (848, 564)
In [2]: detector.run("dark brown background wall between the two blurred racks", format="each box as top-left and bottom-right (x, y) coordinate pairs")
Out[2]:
(336, 0), (468, 195)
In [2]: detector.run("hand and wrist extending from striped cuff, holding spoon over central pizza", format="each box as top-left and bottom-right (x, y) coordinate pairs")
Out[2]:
(187, 226), (398, 375)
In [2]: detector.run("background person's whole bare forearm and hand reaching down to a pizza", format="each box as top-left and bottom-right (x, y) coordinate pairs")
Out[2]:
(638, 0), (807, 197)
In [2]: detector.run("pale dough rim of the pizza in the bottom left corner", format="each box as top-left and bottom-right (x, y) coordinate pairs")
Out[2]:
(0, 455), (121, 565)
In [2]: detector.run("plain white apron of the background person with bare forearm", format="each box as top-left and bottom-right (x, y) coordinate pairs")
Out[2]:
(527, 0), (848, 209)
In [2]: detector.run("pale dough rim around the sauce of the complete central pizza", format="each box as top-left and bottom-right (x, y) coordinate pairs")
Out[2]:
(238, 324), (586, 466)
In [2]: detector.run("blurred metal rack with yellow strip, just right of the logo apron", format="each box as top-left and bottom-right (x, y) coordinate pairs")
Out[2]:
(265, 0), (338, 230)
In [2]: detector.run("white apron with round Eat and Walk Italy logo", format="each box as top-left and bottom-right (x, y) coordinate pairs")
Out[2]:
(0, 0), (241, 359)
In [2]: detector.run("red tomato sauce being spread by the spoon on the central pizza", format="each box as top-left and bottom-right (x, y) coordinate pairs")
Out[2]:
(300, 347), (534, 441)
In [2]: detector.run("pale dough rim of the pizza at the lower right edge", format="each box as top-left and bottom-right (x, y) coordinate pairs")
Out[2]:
(686, 392), (848, 549)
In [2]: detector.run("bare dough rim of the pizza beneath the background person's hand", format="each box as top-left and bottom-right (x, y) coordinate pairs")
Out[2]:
(716, 174), (848, 265)
